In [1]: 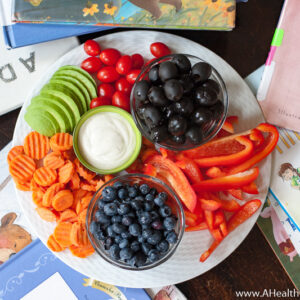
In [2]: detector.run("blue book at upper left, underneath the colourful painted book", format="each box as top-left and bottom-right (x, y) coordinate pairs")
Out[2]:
(0, 0), (110, 49)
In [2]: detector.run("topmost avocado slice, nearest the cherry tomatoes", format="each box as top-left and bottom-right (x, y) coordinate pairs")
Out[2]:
(54, 66), (97, 99)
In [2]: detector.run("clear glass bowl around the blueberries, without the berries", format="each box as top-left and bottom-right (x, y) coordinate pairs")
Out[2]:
(86, 174), (185, 271)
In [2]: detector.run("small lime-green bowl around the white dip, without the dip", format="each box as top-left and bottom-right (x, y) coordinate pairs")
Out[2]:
(73, 105), (142, 174)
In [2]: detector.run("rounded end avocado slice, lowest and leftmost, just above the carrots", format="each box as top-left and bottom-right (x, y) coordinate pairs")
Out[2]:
(24, 109), (58, 136)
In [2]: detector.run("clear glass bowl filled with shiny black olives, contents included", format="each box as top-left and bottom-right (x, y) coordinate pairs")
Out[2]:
(130, 54), (228, 151)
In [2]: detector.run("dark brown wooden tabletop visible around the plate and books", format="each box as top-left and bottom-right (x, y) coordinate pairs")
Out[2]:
(0, 0), (294, 299)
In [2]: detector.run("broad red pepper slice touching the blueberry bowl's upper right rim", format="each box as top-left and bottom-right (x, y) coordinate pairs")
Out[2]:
(147, 155), (197, 212)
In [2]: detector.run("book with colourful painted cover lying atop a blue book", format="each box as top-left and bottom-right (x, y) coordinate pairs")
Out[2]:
(13, 0), (235, 30)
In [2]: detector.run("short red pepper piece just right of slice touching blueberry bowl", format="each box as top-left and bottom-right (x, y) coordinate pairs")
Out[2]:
(176, 153), (203, 184)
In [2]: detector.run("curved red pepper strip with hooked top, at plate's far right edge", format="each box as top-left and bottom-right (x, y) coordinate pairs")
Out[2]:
(229, 123), (279, 174)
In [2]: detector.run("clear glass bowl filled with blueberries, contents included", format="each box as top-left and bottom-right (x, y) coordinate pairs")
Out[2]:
(86, 174), (185, 271)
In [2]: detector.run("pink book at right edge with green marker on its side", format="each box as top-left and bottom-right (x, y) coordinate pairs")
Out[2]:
(257, 0), (300, 131)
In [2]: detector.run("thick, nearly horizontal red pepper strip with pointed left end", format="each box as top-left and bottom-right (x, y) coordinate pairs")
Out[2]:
(193, 167), (259, 192)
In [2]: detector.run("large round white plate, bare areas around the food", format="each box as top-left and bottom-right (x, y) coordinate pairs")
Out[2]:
(13, 31), (271, 288)
